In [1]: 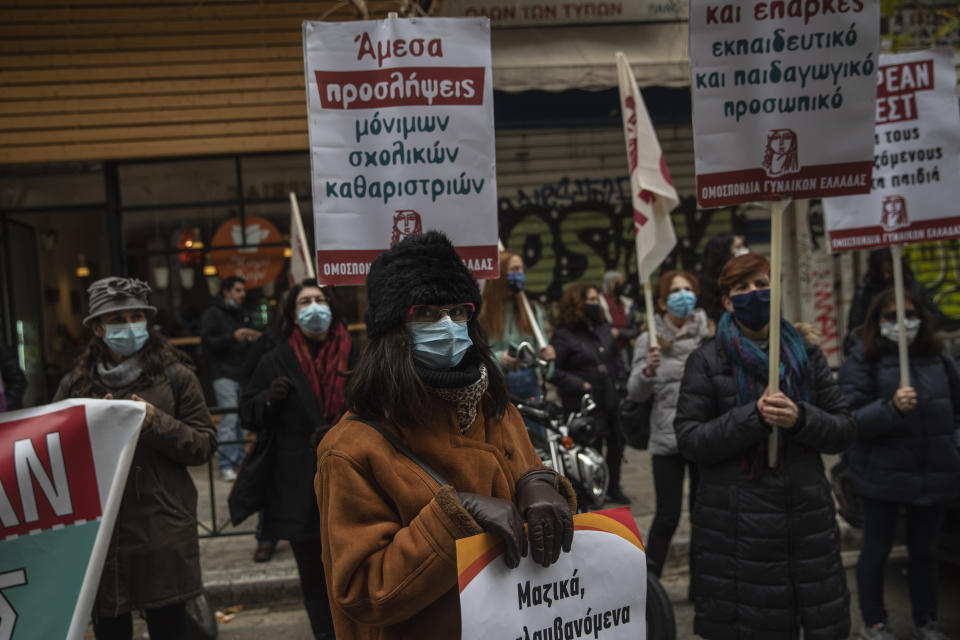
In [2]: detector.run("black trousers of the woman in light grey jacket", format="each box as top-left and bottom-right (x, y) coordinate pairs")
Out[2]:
(647, 453), (699, 577)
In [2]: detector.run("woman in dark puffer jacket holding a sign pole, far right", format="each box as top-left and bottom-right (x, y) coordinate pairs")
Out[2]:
(839, 289), (960, 640)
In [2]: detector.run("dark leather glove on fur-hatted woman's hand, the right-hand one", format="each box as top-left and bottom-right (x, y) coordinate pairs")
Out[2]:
(517, 469), (573, 567)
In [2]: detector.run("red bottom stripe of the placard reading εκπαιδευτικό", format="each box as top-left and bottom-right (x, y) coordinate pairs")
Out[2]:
(697, 161), (873, 207)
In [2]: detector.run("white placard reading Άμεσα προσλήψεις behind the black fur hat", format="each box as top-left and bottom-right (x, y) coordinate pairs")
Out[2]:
(303, 18), (499, 284)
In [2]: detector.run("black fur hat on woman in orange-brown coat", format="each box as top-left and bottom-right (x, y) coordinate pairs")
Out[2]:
(366, 231), (481, 340)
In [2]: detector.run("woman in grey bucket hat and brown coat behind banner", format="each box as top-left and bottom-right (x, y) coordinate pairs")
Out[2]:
(54, 277), (217, 640)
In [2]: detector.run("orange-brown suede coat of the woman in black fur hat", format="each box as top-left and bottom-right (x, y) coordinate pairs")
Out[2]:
(315, 399), (568, 640)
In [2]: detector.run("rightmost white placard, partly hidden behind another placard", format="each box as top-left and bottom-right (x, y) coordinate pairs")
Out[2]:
(823, 49), (960, 251)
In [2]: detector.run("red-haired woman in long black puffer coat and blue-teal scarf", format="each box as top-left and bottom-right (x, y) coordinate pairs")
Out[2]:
(674, 254), (854, 640)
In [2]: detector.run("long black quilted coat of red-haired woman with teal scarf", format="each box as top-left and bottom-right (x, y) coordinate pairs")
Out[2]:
(674, 339), (854, 640)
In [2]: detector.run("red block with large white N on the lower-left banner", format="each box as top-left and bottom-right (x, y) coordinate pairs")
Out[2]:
(0, 406), (101, 540)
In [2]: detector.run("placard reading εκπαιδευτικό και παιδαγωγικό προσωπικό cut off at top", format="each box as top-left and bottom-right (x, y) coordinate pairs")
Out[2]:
(690, 0), (880, 207)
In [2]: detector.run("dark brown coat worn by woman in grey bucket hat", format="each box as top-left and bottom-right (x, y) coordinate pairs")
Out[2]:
(54, 364), (217, 616)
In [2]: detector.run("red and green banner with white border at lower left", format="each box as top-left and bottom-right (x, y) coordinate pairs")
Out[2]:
(0, 400), (145, 640)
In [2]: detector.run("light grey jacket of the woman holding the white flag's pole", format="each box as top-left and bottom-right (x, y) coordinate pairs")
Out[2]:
(627, 309), (710, 456)
